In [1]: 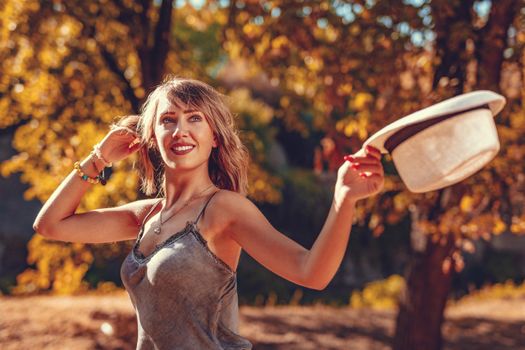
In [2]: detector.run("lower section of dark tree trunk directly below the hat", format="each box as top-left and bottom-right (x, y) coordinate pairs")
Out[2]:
(393, 197), (454, 350)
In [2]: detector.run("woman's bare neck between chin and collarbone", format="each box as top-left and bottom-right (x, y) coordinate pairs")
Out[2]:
(164, 167), (213, 208)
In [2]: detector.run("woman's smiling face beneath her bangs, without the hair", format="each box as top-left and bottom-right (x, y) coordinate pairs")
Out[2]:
(154, 96), (217, 170)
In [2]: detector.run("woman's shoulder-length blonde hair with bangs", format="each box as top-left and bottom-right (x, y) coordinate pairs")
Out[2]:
(116, 77), (249, 196)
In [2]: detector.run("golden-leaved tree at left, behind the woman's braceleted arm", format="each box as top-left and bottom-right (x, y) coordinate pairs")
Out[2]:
(0, 0), (279, 293)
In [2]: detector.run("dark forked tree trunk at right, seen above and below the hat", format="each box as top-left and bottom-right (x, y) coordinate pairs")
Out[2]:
(393, 0), (517, 350)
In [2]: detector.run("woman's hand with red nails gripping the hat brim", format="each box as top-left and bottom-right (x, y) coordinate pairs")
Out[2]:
(335, 146), (384, 203)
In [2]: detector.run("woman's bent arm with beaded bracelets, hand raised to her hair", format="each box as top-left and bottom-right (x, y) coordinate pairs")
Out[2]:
(33, 120), (144, 243)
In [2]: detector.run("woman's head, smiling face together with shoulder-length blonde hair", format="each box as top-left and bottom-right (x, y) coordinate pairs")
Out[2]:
(134, 79), (248, 195)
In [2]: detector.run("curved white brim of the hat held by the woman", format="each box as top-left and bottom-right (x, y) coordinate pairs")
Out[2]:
(363, 90), (505, 153)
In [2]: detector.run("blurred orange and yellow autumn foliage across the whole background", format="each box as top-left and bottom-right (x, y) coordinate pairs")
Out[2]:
(0, 0), (525, 348)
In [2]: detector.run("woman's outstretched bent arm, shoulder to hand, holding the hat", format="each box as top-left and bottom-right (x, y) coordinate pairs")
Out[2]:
(223, 148), (384, 290)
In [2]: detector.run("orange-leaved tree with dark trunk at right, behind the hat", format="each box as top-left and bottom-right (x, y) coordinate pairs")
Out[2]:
(225, 0), (525, 349)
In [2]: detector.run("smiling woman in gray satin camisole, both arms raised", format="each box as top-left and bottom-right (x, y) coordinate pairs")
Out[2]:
(34, 78), (383, 349)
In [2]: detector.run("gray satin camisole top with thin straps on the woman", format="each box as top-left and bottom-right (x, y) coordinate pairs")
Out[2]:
(120, 191), (252, 350)
